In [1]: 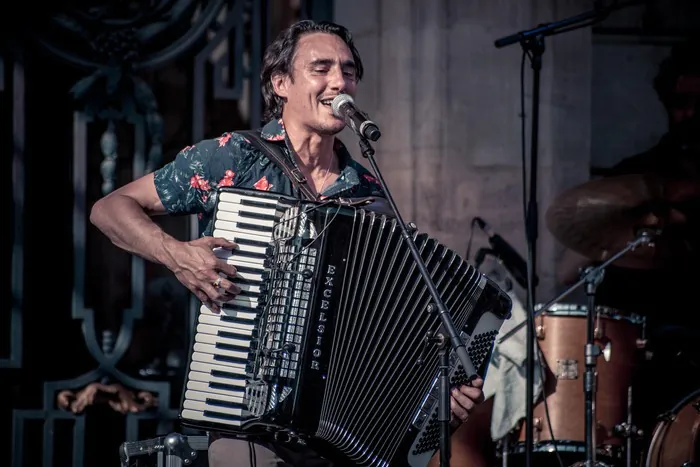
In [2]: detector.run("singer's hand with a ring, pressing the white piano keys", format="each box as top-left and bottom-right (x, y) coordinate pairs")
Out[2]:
(164, 237), (241, 311)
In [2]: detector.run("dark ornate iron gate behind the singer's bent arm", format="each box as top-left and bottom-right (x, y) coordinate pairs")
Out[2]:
(0, 0), (332, 467)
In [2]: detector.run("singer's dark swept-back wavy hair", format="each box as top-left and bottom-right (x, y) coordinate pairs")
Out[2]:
(260, 20), (362, 121)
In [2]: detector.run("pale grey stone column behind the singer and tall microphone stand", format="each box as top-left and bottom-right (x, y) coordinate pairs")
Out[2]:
(335, 0), (591, 301)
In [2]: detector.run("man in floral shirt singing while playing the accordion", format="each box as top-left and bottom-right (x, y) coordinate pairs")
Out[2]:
(91, 21), (483, 467)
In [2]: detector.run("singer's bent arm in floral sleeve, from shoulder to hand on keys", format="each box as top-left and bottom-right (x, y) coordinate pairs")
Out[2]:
(90, 138), (240, 311)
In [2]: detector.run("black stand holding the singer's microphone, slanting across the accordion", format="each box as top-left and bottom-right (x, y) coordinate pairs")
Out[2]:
(355, 135), (477, 467)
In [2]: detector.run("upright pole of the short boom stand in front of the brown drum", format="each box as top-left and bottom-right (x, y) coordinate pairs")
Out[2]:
(583, 268), (604, 467)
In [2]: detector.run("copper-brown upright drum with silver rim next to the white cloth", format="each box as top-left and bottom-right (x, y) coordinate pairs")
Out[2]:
(509, 303), (646, 467)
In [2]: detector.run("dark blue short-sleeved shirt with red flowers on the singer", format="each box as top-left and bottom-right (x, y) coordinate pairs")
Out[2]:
(154, 119), (384, 235)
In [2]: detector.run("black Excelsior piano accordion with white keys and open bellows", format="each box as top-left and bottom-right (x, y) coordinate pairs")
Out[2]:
(179, 187), (511, 466)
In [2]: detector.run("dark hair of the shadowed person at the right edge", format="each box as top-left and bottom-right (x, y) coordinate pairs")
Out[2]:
(654, 36), (700, 105)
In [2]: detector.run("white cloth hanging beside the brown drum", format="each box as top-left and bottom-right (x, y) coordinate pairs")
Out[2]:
(484, 288), (542, 440)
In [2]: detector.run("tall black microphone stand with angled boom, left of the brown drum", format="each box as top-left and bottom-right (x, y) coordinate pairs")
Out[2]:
(494, 0), (643, 467)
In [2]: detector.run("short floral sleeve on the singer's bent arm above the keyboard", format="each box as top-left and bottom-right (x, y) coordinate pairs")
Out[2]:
(154, 133), (241, 215)
